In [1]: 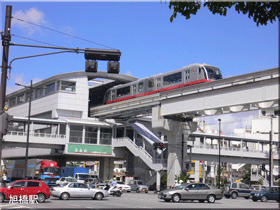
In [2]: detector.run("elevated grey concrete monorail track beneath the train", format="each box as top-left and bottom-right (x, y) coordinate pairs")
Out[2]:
(90, 68), (279, 119)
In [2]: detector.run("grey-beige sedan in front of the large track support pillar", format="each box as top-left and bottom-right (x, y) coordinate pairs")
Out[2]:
(158, 183), (223, 203)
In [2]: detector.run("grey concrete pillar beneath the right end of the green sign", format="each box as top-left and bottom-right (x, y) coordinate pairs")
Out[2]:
(99, 158), (114, 180)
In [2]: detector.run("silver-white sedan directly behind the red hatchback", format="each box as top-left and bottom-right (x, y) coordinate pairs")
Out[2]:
(51, 182), (109, 200)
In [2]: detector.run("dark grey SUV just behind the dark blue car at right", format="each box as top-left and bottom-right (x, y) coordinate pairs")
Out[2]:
(224, 182), (254, 199)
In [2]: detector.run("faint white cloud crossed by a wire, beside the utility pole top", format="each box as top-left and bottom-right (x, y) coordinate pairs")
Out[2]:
(12, 8), (46, 35)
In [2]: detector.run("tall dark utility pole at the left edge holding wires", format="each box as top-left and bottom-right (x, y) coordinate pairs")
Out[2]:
(0, 5), (12, 169)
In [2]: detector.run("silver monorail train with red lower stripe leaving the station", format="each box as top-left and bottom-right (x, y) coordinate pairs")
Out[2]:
(104, 64), (223, 104)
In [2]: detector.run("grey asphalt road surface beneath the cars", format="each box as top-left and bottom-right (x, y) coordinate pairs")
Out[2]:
(0, 192), (279, 209)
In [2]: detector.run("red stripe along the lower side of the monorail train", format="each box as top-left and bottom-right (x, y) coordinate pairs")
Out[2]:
(104, 79), (211, 104)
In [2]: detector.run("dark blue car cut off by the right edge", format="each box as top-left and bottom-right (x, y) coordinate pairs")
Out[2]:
(250, 187), (280, 202)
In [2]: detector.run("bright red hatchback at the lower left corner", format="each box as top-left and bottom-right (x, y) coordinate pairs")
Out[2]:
(0, 180), (50, 203)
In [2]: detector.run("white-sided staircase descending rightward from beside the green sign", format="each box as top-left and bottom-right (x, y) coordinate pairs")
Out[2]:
(113, 137), (163, 171)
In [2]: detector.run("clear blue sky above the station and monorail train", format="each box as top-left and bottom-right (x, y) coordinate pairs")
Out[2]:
(0, 1), (279, 135)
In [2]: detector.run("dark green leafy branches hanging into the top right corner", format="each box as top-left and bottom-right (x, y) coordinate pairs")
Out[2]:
(169, 0), (280, 26)
